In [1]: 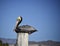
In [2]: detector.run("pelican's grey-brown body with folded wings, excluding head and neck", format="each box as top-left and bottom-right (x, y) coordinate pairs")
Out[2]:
(15, 25), (37, 34)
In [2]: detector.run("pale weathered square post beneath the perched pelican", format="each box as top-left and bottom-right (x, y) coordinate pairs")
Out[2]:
(17, 33), (28, 46)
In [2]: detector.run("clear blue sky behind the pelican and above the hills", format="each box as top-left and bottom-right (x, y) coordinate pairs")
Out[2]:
(0, 0), (60, 41)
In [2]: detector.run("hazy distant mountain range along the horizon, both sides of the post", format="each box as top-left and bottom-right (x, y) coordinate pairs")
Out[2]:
(0, 38), (60, 46)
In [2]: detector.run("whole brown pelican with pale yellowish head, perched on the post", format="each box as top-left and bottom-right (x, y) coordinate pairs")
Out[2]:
(15, 16), (37, 34)
